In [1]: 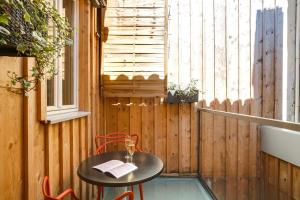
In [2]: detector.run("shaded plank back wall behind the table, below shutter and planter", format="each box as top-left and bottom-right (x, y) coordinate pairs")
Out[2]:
(101, 98), (199, 174)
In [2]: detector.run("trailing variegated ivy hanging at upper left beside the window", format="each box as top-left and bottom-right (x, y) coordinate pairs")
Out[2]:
(0, 0), (72, 95)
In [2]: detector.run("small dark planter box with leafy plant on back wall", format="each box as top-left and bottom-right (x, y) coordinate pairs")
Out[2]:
(167, 79), (199, 103)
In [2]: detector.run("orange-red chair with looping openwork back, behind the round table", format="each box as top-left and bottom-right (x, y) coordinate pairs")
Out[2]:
(95, 132), (144, 200)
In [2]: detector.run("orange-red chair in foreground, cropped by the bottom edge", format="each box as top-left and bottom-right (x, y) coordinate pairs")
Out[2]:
(42, 176), (134, 200)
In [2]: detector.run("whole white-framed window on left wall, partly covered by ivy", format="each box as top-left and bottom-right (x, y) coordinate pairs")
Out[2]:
(47, 0), (78, 114)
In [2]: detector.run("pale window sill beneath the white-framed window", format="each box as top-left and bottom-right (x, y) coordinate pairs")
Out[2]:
(44, 111), (91, 124)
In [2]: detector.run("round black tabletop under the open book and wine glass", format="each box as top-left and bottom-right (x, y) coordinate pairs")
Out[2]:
(77, 152), (164, 187)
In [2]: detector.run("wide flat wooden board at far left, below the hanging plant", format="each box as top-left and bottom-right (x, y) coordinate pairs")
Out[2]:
(0, 58), (25, 199)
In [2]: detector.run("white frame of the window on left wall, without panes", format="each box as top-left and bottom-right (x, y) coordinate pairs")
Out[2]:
(47, 0), (79, 116)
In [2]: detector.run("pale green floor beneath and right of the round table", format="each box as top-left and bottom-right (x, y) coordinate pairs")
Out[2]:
(105, 177), (212, 200)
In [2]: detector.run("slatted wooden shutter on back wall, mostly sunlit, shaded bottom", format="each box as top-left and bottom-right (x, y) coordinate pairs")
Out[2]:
(103, 0), (167, 97)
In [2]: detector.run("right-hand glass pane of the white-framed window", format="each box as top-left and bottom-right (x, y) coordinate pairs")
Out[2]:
(61, 0), (75, 105)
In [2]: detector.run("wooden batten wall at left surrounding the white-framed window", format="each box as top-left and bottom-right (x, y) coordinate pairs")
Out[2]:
(0, 0), (102, 200)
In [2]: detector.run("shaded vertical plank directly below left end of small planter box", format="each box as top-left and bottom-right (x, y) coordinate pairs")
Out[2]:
(167, 104), (179, 173)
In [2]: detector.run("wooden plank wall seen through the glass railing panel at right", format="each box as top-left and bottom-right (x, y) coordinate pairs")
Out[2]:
(199, 109), (300, 200)
